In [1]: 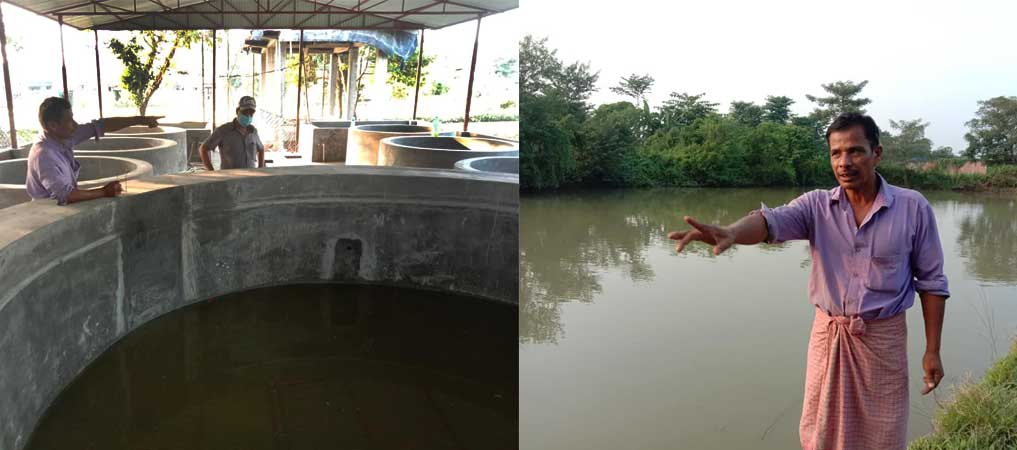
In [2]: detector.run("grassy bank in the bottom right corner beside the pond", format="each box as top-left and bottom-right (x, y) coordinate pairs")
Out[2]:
(908, 341), (1017, 450)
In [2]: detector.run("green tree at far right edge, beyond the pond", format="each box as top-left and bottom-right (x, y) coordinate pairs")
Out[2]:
(964, 97), (1017, 164)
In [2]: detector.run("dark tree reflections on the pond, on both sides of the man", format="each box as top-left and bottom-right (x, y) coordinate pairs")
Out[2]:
(520, 189), (1017, 343)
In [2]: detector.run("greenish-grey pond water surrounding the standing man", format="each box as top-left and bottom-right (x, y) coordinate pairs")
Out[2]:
(519, 189), (1017, 450)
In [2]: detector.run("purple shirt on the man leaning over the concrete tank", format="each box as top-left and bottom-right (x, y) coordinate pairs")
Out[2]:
(24, 120), (103, 205)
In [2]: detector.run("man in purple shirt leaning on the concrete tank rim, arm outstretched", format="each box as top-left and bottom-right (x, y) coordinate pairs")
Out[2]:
(24, 97), (159, 205)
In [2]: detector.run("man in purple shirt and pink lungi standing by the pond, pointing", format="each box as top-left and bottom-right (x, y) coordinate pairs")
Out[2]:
(668, 113), (950, 450)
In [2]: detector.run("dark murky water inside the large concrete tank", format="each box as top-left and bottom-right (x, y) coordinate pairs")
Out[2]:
(27, 285), (519, 450)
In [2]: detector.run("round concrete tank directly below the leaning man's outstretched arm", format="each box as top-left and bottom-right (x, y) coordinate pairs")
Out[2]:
(74, 137), (178, 175)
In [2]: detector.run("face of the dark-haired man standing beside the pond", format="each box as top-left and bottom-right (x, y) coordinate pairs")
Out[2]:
(830, 125), (883, 190)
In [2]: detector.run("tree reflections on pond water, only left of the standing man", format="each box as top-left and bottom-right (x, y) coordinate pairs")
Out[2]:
(520, 189), (809, 343)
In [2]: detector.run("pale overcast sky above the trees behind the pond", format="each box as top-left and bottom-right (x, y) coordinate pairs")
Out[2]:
(521, 0), (1017, 152)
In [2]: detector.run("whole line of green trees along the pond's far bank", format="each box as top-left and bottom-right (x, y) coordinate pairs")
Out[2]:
(520, 37), (1017, 190)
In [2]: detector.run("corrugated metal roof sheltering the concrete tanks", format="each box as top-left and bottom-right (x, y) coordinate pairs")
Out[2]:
(1, 0), (519, 30)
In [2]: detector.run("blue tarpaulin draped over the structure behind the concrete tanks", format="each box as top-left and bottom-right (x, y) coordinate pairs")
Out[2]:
(251, 30), (417, 60)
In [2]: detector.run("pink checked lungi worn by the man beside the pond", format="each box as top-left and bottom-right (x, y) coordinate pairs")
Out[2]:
(798, 308), (908, 450)
